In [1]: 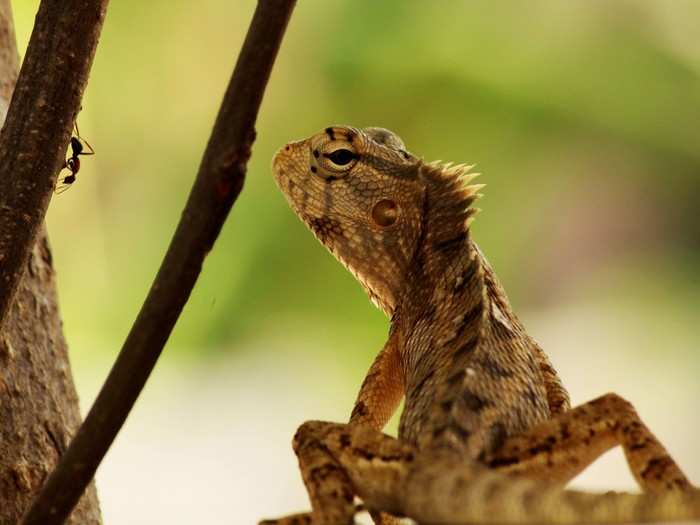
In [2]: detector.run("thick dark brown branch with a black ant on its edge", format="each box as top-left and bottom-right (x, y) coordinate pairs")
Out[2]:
(0, 0), (108, 329)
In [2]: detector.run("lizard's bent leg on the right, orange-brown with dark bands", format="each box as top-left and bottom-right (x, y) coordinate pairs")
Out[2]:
(486, 394), (693, 493)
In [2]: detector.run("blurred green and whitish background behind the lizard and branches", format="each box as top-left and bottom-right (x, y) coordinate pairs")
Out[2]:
(14, 0), (700, 523)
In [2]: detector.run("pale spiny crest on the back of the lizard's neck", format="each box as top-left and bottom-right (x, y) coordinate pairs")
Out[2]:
(421, 161), (484, 252)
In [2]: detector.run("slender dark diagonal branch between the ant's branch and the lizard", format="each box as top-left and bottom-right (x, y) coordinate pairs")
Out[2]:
(23, 0), (295, 525)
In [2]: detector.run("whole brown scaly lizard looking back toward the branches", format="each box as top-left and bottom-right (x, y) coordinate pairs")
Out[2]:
(264, 127), (700, 525)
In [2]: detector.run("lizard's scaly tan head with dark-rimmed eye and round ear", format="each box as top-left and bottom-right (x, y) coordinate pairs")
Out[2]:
(272, 126), (482, 315)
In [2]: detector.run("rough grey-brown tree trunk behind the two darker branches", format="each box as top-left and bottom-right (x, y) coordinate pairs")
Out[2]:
(0, 4), (101, 525)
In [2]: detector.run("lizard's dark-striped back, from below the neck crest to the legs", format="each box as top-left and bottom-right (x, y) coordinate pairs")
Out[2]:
(393, 225), (550, 458)
